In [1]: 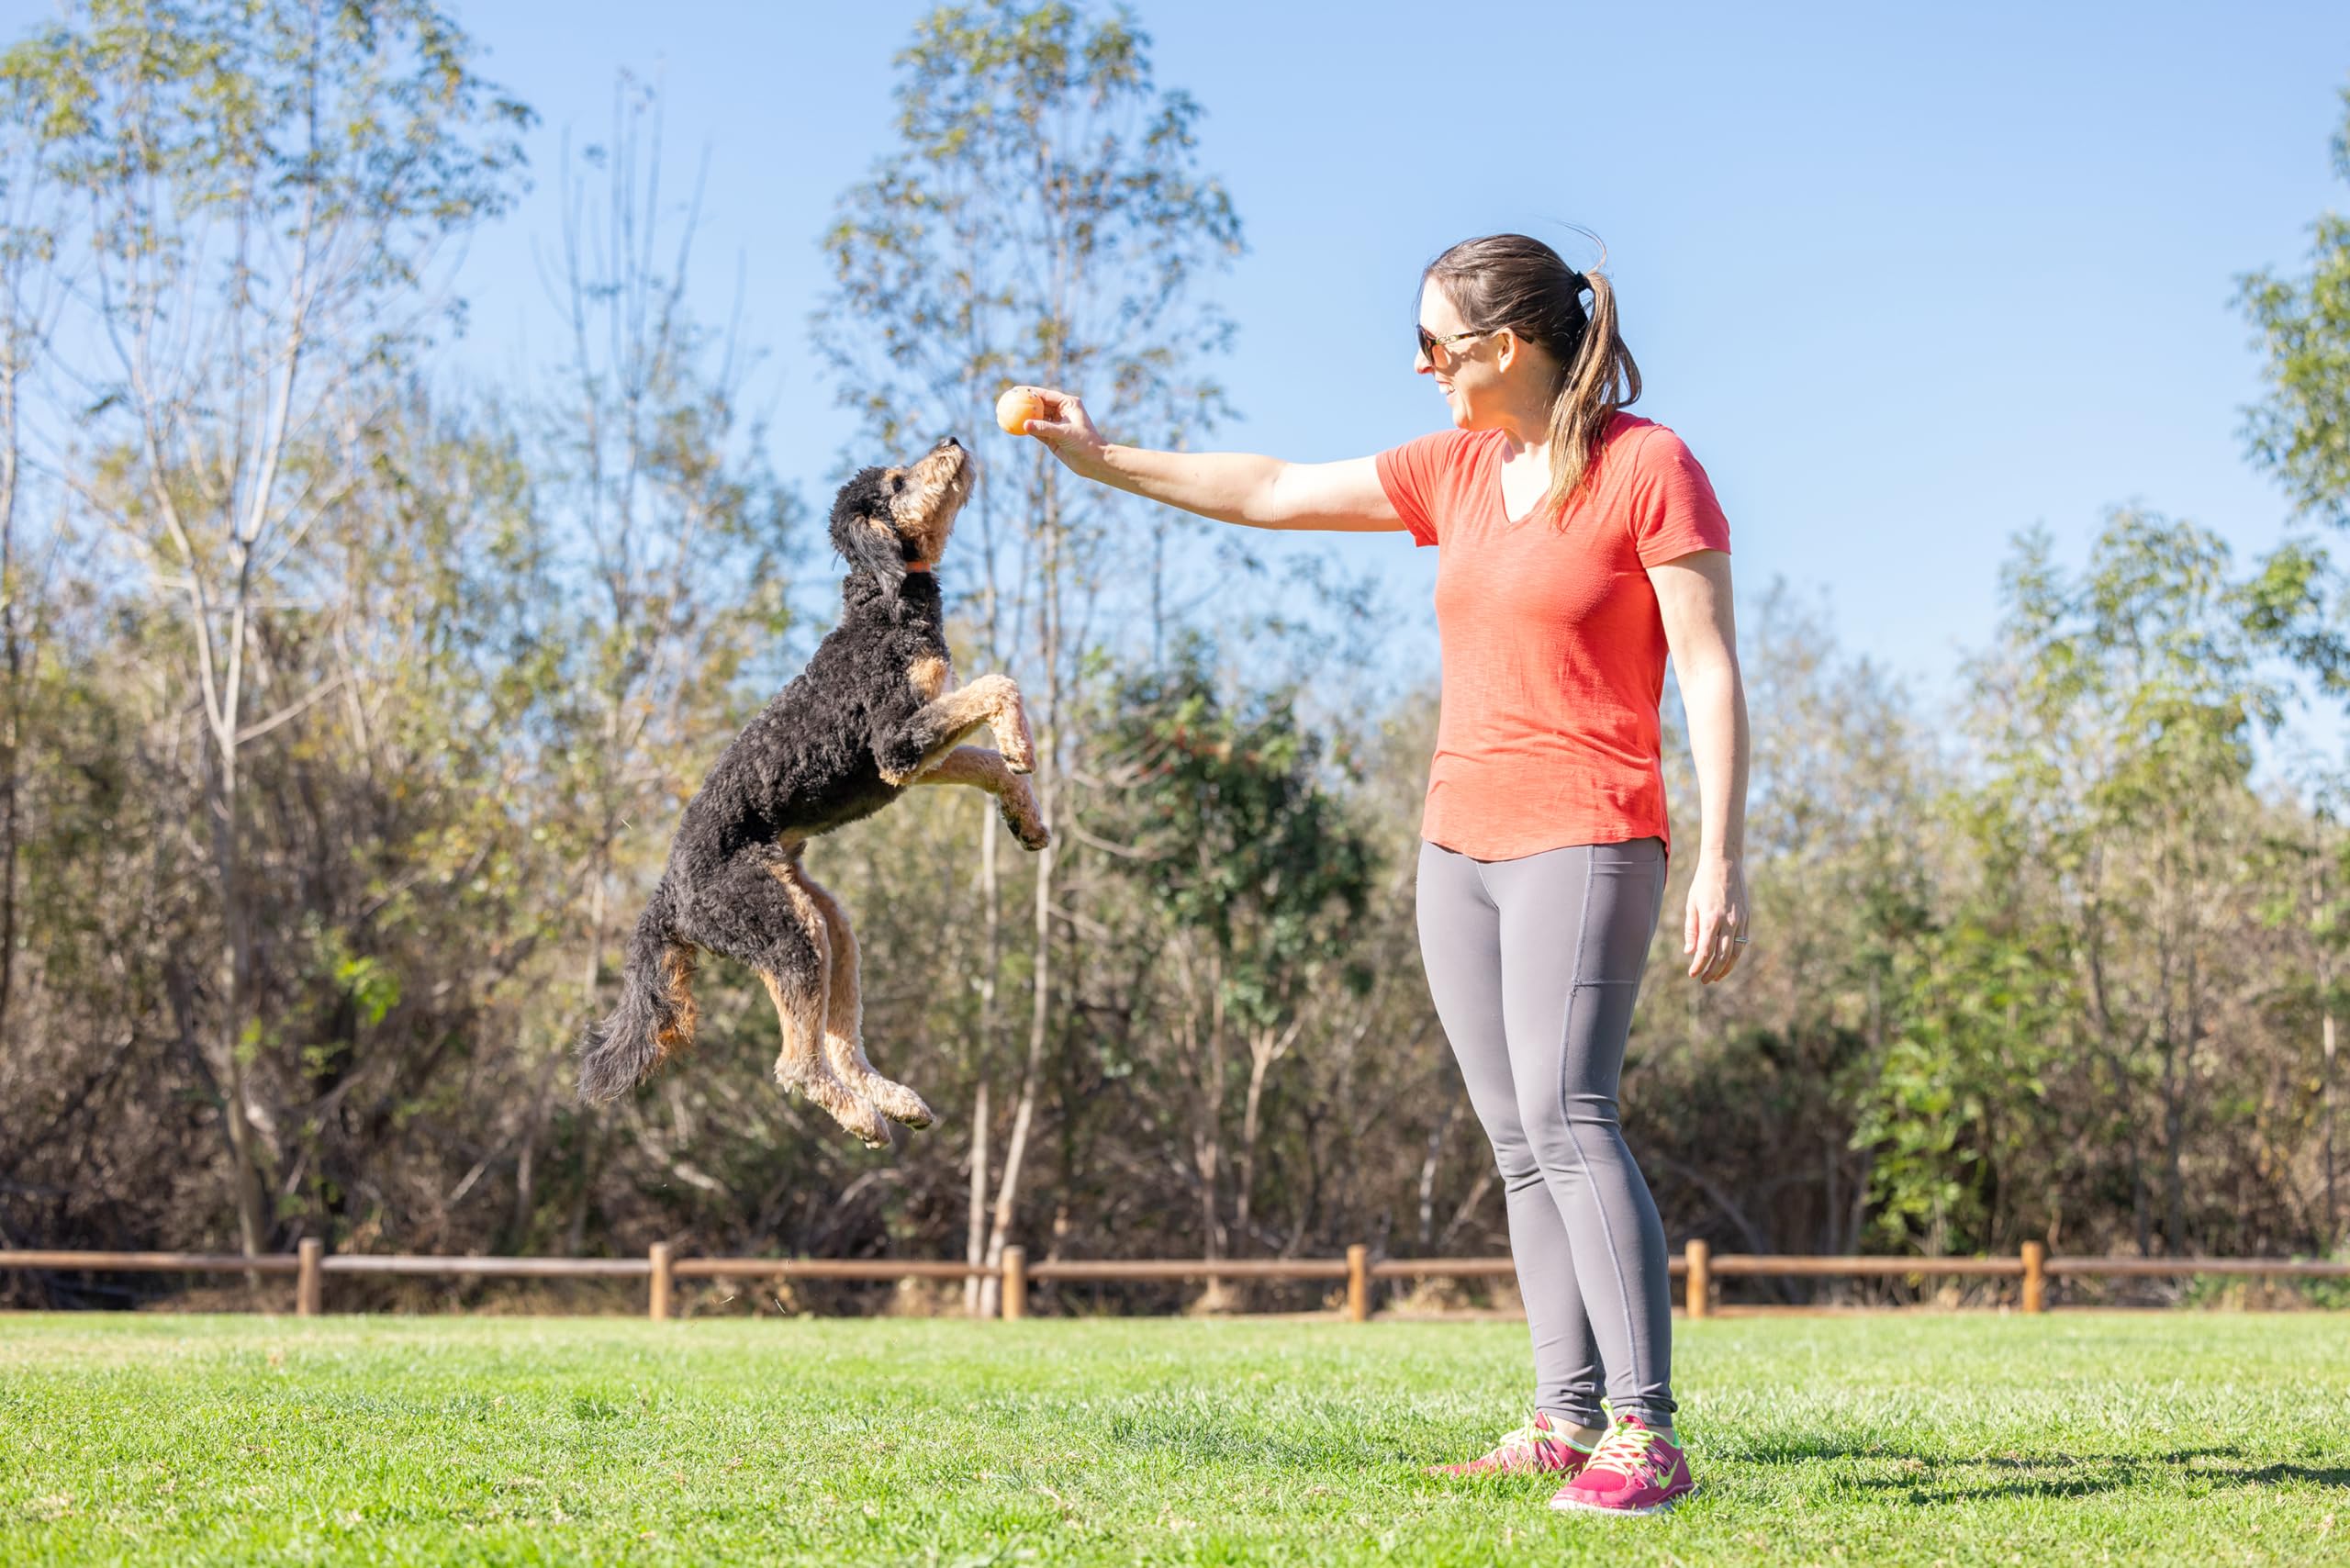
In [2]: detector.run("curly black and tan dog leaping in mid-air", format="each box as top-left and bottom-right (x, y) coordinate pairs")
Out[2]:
(580, 435), (1050, 1145)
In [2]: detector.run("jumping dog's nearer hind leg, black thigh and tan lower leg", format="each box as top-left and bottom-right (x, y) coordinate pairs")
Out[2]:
(691, 844), (890, 1148)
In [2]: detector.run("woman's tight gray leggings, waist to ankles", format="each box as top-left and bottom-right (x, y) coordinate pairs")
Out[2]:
(1419, 839), (1673, 1427)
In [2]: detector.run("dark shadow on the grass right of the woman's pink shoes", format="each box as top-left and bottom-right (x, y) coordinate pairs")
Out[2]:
(1722, 1443), (2350, 1502)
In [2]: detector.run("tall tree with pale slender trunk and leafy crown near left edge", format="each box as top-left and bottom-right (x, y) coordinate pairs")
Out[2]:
(0, 0), (529, 1253)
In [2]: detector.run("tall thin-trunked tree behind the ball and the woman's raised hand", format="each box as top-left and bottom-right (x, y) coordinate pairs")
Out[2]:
(813, 0), (1241, 1312)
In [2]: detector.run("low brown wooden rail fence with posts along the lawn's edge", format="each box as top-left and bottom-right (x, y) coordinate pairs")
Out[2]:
(0, 1238), (2350, 1324)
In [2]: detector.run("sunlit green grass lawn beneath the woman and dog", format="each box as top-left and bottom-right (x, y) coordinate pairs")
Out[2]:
(0, 1314), (2350, 1565)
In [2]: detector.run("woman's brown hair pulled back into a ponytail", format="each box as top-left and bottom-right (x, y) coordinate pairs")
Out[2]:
(1422, 235), (1640, 527)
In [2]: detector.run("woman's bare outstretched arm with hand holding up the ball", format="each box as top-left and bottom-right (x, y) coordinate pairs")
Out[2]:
(1027, 388), (1403, 533)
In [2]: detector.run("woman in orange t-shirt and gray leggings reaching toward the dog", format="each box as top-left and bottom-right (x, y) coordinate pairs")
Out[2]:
(1027, 235), (1746, 1514)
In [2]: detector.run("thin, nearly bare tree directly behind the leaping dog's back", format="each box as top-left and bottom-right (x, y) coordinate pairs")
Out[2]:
(515, 85), (794, 1250)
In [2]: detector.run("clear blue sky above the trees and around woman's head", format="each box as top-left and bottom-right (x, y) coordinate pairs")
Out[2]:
(0, 0), (2350, 728)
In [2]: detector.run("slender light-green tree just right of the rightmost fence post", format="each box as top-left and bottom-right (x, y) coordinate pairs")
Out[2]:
(1976, 521), (2282, 1253)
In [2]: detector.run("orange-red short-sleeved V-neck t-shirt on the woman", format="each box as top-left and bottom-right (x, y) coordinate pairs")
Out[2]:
(1377, 414), (1729, 860)
